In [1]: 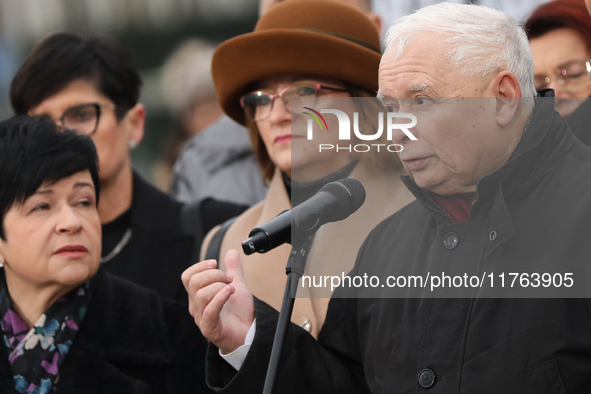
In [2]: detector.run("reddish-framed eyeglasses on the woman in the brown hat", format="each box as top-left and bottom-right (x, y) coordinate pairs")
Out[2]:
(240, 83), (348, 122)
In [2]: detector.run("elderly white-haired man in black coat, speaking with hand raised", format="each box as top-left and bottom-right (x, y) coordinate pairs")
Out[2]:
(183, 3), (591, 393)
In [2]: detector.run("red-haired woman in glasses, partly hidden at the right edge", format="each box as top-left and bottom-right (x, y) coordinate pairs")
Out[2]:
(524, 0), (591, 117)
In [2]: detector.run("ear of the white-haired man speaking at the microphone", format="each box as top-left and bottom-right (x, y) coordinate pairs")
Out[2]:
(491, 71), (521, 127)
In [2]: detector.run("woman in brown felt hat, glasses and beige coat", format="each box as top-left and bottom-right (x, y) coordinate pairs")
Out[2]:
(197, 0), (413, 337)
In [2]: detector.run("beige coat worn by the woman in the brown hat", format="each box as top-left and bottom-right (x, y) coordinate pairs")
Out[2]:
(201, 163), (414, 338)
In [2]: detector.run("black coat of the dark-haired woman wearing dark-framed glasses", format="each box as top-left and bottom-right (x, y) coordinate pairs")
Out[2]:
(104, 173), (247, 303)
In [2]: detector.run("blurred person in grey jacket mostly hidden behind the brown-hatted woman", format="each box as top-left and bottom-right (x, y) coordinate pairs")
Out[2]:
(170, 0), (382, 205)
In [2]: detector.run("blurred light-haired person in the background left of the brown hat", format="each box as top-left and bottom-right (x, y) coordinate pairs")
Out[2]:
(154, 39), (222, 191)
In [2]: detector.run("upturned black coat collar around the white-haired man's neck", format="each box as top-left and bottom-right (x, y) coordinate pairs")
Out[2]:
(403, 90), (575, 221)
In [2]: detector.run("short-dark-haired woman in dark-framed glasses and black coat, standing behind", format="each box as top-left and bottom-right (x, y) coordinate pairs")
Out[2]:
(10, 33), (241, 302)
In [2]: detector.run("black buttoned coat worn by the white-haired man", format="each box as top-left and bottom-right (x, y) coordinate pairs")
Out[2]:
(207, 93), (591, 394)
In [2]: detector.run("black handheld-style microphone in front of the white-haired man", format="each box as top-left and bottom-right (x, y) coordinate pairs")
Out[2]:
(242, 178), (365, 255)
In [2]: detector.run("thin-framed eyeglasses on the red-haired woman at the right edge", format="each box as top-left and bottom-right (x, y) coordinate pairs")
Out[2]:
(534, 60), (591, 93)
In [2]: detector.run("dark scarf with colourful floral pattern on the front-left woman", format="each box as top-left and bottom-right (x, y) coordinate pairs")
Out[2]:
(0, 270), (91, 394)
